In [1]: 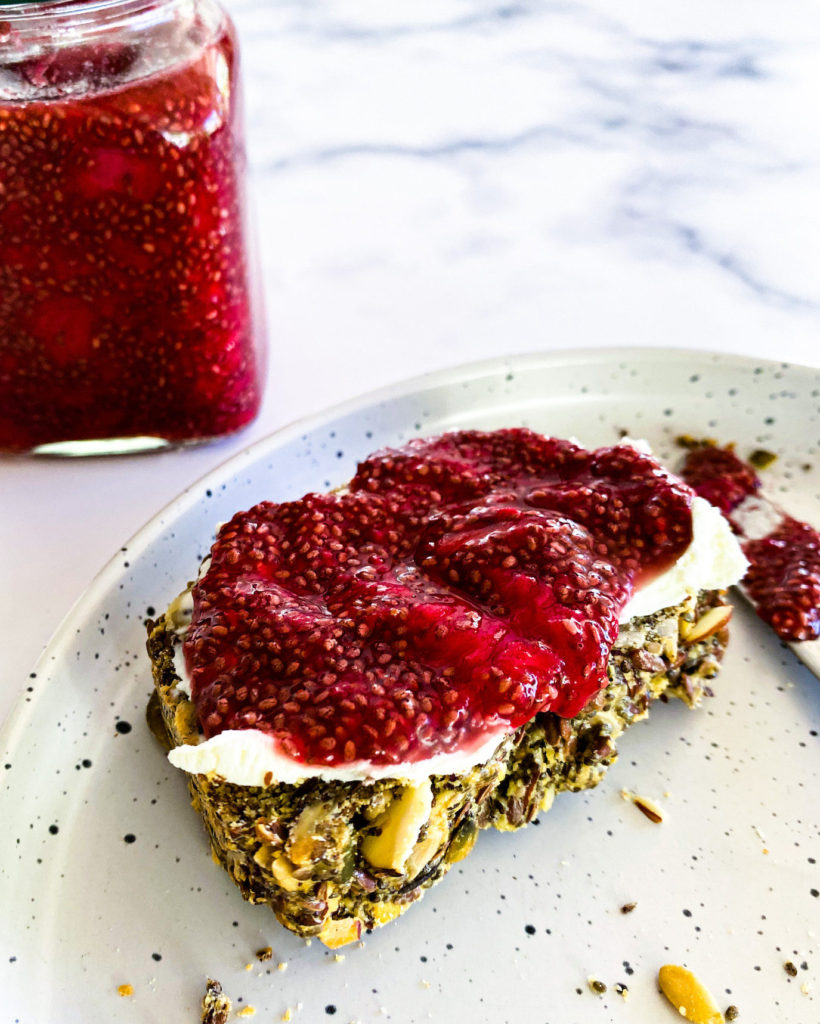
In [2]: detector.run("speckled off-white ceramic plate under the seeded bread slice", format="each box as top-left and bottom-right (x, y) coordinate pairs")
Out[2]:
(0, 350), (820, 1024)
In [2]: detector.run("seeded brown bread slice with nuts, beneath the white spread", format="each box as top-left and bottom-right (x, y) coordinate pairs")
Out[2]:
(147, 591), (731, 947)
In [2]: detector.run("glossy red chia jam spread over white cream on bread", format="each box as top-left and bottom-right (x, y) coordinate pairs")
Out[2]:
(183, 429), (693, 766)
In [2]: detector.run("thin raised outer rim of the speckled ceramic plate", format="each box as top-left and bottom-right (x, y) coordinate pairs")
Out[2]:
(0, 345), (820, 753)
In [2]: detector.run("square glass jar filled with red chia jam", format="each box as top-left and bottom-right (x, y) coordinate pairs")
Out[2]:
(0, 0), (264, 455)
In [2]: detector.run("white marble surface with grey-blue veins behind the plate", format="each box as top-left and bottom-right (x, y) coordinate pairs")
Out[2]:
(0, 0), (820, 721)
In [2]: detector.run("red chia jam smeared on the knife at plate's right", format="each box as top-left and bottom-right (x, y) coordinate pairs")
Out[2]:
(681, 447), (820, 641)
